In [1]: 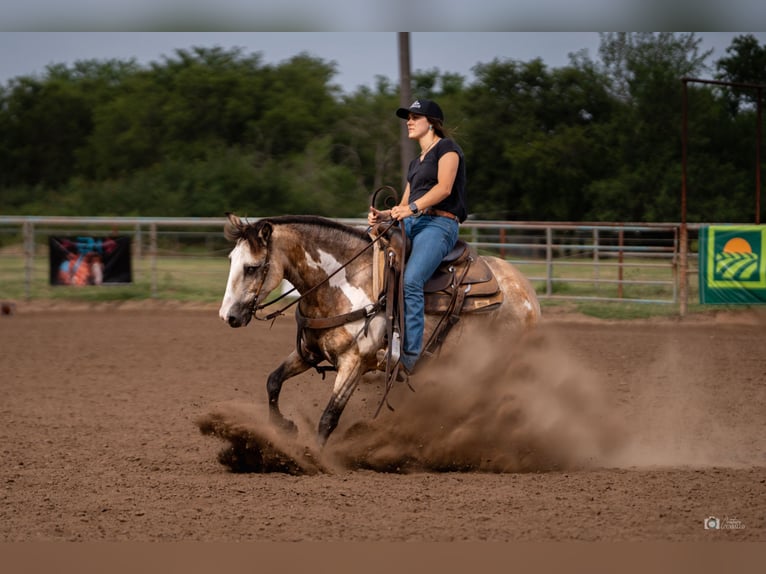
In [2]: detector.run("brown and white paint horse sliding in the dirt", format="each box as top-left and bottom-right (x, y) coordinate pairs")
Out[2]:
(219, 214), (540, 446)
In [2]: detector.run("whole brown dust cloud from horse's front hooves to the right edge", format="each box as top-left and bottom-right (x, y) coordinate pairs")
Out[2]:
(200, 320), (766, 473)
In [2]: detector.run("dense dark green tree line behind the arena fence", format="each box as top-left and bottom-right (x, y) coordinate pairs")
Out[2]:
(0, 33), (766, 221)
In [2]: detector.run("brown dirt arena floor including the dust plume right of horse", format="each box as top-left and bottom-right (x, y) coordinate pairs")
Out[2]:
(0, 303), (766, 542)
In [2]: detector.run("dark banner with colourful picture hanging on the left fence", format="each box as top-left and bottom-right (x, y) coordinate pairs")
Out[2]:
(48, 236), (132, 285)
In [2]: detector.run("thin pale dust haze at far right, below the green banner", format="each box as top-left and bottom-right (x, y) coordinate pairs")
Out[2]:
(610, 334), (766, 468)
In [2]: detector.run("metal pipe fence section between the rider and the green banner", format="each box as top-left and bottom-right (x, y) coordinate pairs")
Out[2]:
(468, 222), (696, 304)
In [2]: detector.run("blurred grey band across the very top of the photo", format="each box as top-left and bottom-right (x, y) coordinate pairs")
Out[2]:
(0, 0), (766, 32)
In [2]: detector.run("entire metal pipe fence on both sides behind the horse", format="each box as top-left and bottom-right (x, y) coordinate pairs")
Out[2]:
(0, 216), (699, 316)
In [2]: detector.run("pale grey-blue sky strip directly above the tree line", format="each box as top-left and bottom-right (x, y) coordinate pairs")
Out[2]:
(0, 31), (766, 93)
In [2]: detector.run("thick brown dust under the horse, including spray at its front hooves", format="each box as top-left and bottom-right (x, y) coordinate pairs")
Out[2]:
(197, 332), (627, 473)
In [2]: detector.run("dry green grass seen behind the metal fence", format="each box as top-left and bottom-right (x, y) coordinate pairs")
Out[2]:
(0, 250), (756, 320)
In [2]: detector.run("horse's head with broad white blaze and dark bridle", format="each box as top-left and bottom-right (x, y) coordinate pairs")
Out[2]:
(218, 213), (282, 327)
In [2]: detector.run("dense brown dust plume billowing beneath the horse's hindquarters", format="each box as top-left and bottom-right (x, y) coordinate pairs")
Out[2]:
(338, 332), (624, 472)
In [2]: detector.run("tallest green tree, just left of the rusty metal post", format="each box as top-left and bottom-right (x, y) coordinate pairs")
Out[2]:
(589, 32), (710, 221)
